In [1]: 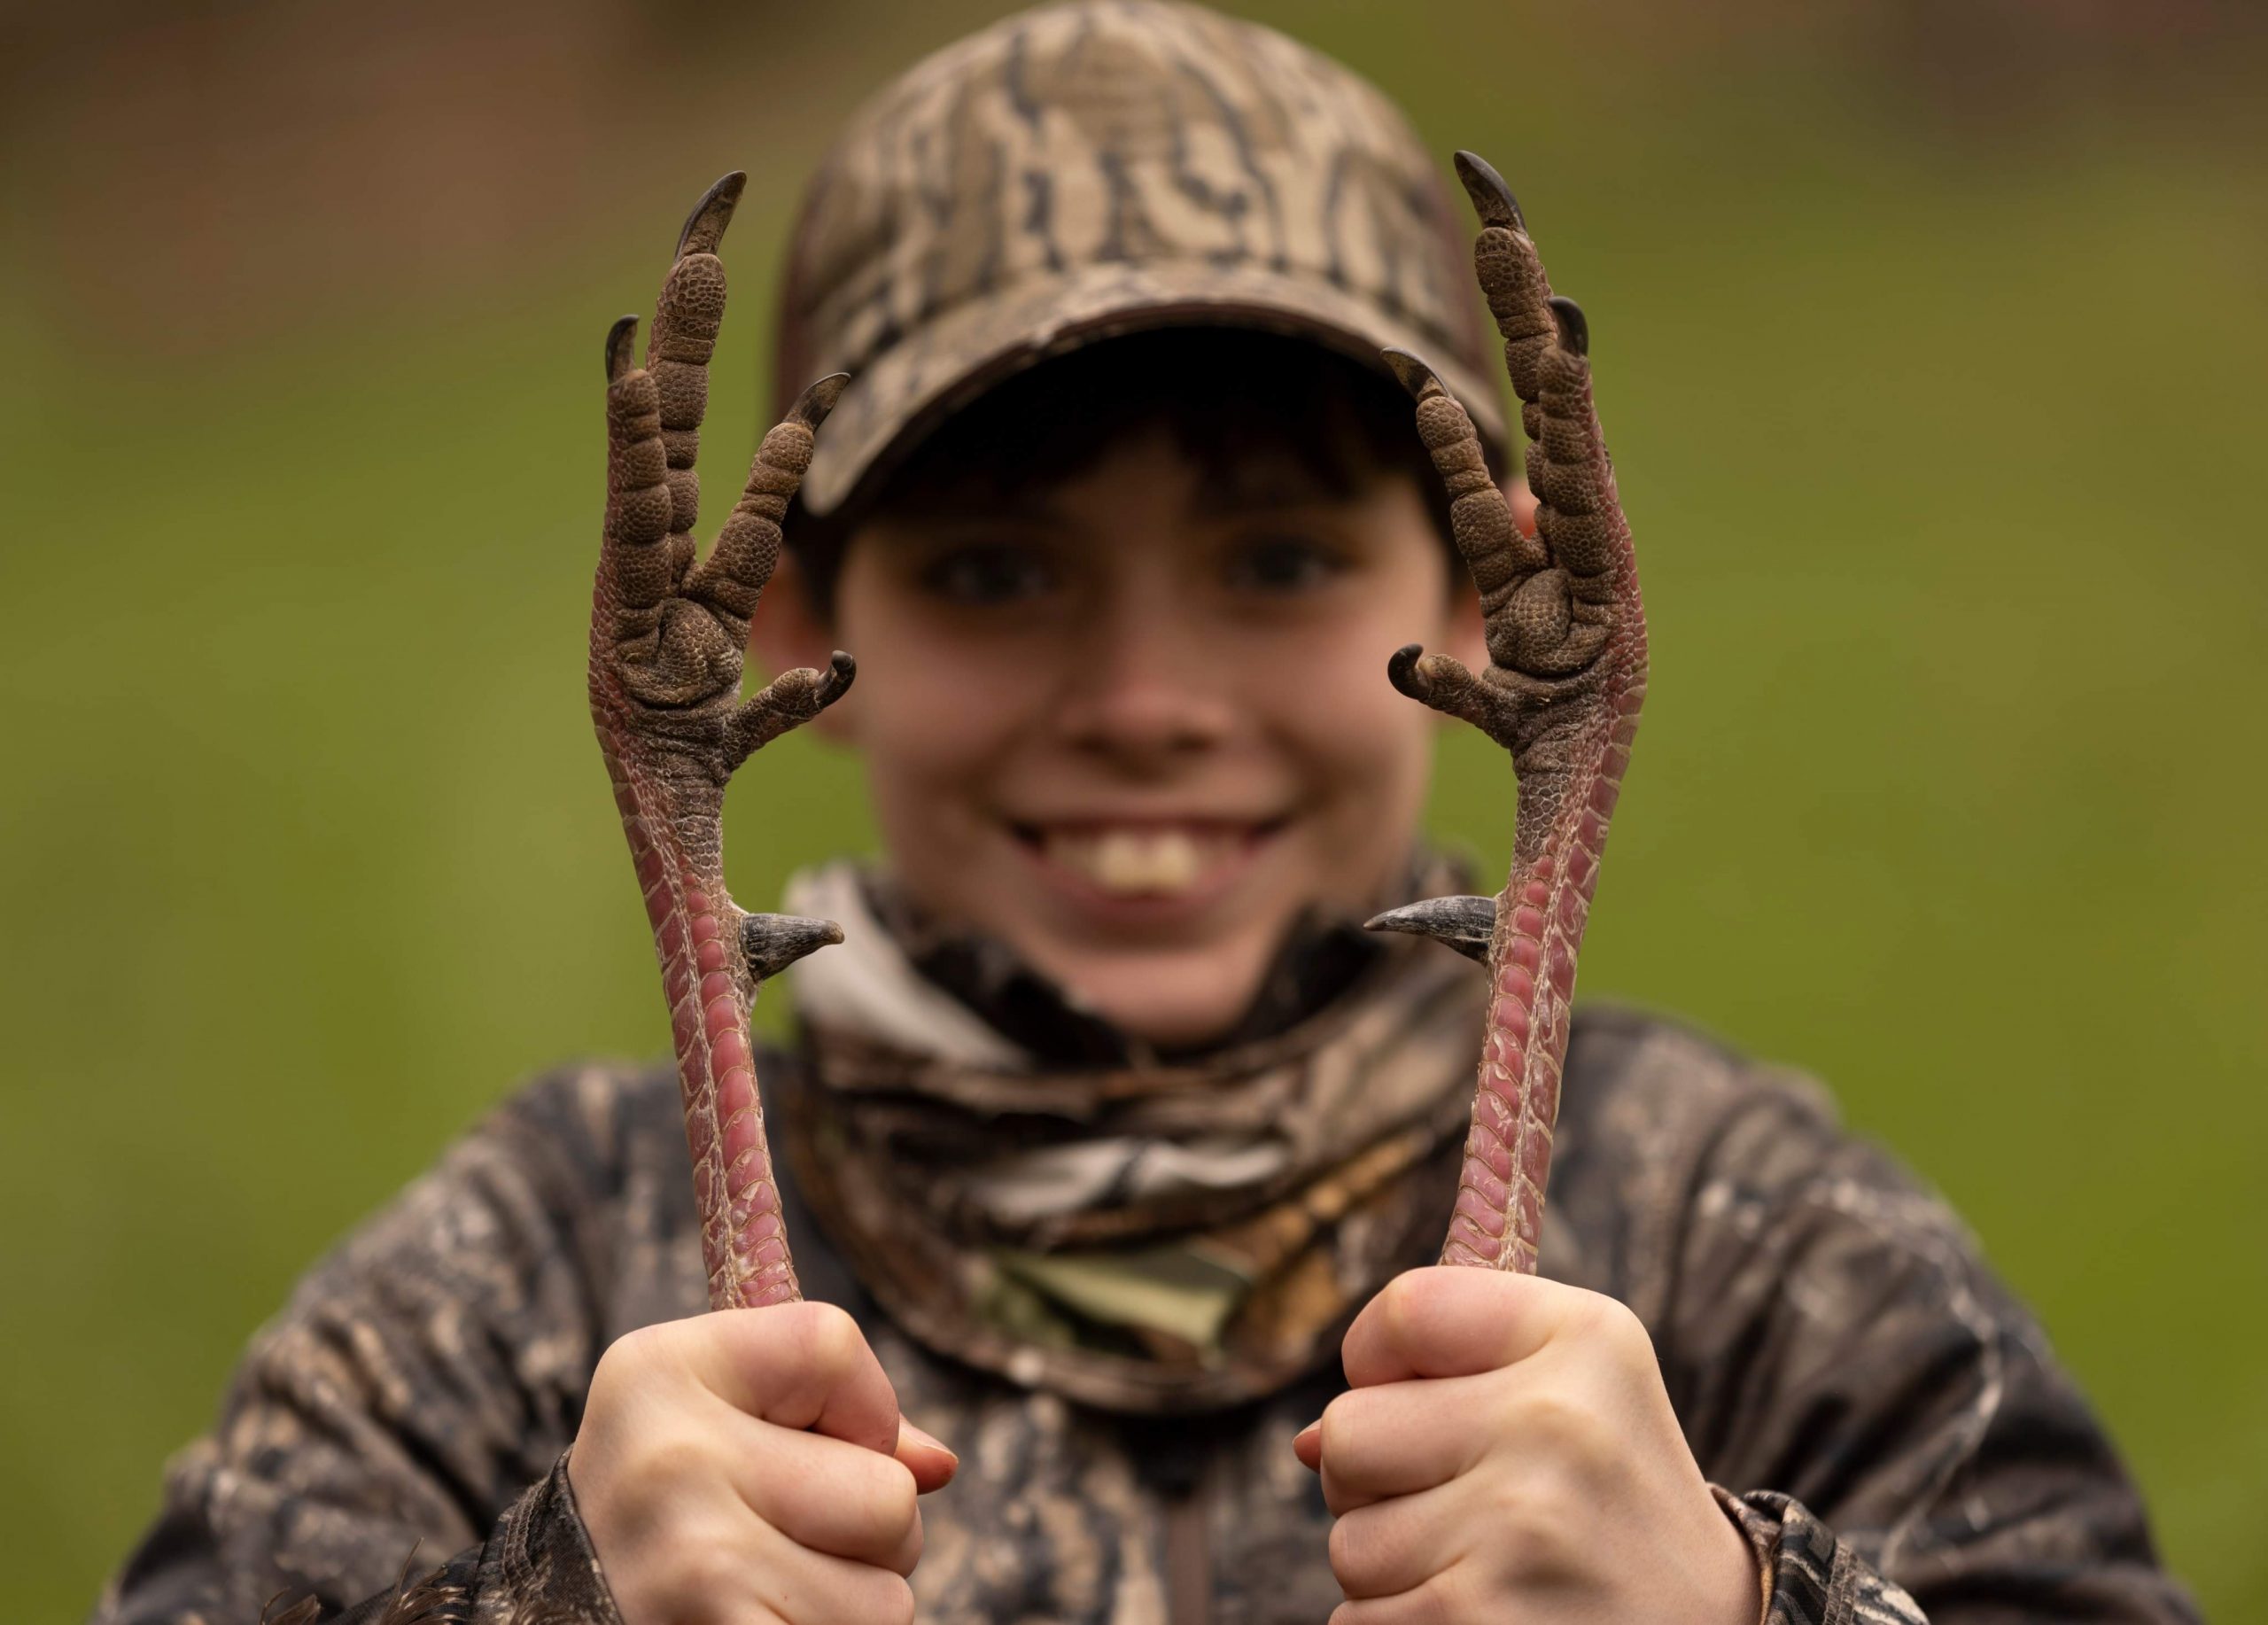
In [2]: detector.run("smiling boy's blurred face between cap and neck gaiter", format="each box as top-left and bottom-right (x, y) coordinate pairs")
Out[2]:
(755, 432), (1486, 1044)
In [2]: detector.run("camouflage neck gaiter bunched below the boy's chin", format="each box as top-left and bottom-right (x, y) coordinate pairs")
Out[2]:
(778, 860), (1483, 1414)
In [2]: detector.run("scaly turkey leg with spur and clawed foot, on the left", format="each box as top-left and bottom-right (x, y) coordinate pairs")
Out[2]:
(590, 175), (855, 1310)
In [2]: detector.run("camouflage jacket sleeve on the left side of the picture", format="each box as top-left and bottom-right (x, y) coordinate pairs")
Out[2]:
(93, 1071), (683, 1625)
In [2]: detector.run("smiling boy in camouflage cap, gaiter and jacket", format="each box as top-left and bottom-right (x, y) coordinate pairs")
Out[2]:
(97, 0), (2191, 1625)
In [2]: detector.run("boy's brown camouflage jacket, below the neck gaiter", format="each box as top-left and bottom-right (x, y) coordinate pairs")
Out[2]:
(96, 1010), (2195, 1625)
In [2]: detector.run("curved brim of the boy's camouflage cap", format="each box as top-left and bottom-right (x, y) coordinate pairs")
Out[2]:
(803, 263), (1506, 513)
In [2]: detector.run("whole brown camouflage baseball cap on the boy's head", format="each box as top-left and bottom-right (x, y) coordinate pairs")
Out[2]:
(773, 0), (1503, 513)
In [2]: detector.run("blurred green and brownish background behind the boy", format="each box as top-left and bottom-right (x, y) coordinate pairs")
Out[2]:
(0, 0), (2268, 1621)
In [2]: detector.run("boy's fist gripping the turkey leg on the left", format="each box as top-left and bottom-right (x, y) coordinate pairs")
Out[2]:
(567, 1302), (957, 1625)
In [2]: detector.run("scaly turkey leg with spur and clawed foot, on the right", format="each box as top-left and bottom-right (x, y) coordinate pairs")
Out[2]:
(1370, 152), (1647, 1276)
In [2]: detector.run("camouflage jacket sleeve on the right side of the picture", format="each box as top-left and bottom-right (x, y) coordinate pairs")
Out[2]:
(1656, 1061), (2198, 1625)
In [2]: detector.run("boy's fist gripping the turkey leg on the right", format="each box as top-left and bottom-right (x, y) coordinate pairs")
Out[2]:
(1293, 1269), (1762, 1625)
